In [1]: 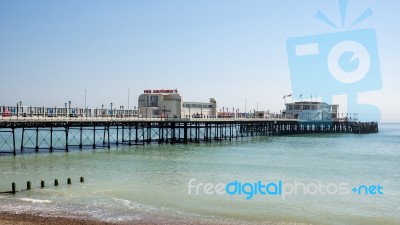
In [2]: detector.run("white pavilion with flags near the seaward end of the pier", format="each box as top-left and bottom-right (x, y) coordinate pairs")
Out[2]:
(283, 101), (339, 121)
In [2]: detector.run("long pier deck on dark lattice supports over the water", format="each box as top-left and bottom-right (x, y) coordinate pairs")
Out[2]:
(0, 117), (378, 155)
